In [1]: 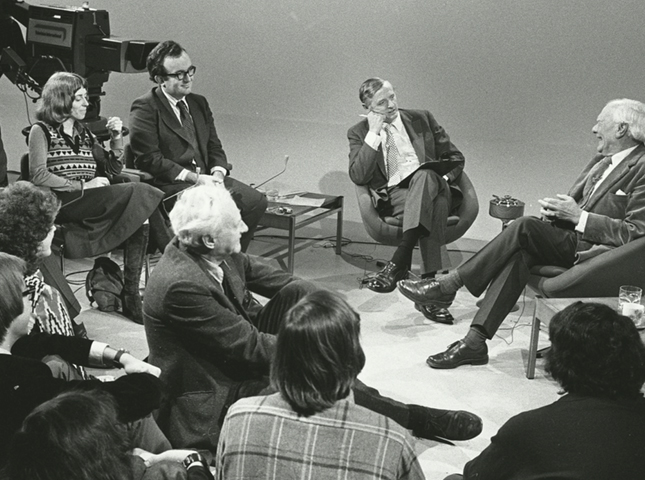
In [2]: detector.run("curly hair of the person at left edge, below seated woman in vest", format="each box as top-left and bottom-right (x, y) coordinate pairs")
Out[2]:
(0, 182), (60, 274)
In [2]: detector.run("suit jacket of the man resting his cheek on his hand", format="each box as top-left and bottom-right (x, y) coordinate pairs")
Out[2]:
(347, 109), (464, 203)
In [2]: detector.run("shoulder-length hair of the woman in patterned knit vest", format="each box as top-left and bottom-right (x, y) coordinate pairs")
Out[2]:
(36, 72), (87, 127)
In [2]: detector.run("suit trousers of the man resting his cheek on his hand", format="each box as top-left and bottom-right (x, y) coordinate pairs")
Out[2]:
(382, 169), (452, 272)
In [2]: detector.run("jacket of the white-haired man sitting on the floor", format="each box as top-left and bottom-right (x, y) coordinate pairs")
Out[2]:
(143, 239), (294, 452)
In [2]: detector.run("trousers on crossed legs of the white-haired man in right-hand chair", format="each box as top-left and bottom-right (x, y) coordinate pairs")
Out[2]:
(457, 217), (578, 339)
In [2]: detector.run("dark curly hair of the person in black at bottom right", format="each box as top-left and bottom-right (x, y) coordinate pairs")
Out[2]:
(546, 302), (645, 398)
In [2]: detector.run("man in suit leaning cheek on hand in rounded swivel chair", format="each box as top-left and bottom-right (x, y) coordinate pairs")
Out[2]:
(347, 78), (464, 323)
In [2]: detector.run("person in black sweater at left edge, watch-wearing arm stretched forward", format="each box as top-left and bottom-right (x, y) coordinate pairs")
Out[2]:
(0, 253), (170, 468)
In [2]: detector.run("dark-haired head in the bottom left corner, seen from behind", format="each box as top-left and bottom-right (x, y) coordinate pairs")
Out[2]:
(7, 391), (132, 480)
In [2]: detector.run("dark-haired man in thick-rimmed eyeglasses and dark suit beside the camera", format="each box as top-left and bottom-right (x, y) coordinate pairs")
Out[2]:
(130, 40), (267, 251)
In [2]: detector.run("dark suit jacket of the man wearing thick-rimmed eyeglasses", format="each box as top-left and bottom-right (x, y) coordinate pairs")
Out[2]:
(130, 87), (228, 185)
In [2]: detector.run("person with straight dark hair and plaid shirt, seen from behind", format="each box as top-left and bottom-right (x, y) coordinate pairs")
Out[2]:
(217, 291), (425, 480)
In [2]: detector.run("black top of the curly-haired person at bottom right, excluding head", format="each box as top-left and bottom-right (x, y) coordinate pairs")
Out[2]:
(464, 394), (645, 480)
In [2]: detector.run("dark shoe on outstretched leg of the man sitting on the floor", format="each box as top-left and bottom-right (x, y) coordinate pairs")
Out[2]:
(409, 405), (482, 440)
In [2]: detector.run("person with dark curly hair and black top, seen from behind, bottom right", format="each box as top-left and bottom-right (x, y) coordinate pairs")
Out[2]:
(446, 302), (645, 480)
